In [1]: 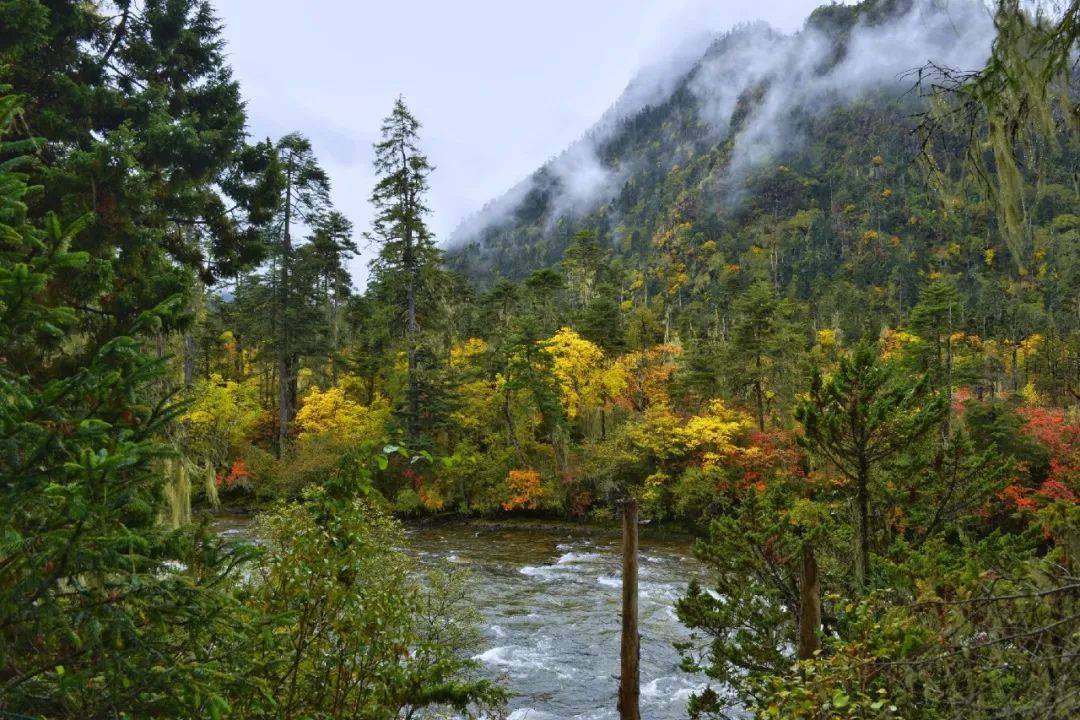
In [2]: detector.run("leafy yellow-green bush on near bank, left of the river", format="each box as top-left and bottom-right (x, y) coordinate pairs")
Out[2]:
(232, 490), (504, 720)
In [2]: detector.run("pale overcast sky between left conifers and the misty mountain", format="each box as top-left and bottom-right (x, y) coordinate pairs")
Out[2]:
(215, 0), (824, 284)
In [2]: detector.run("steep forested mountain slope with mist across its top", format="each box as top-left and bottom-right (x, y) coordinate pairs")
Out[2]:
(448, 0), (1078, 360)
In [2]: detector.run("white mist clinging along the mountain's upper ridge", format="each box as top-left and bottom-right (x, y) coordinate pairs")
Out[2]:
(450, 0), (994, 245)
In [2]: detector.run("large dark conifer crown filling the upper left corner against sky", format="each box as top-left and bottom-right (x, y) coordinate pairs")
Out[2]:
(0, 0), (270, 304)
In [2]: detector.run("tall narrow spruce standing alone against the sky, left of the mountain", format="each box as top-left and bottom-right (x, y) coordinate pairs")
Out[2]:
(370, 97), (438, 440)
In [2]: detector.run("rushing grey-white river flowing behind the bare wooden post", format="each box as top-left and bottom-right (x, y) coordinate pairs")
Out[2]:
(216, 515), (702, 720)
